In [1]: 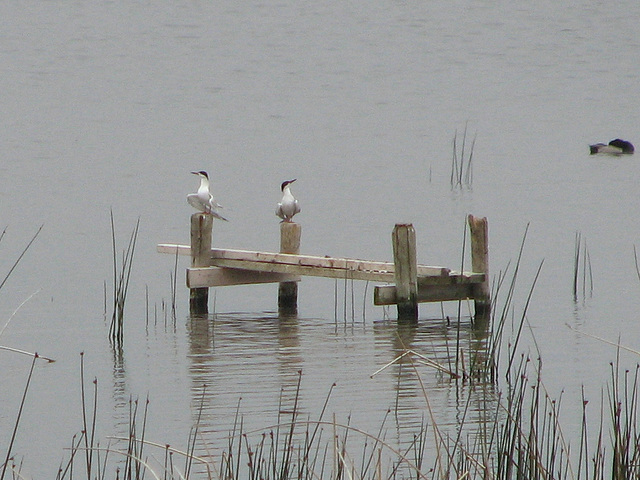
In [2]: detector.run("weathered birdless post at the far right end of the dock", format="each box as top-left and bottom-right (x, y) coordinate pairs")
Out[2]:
(467, 215), (491, 317)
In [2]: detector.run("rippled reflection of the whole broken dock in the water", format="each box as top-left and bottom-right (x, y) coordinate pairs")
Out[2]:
(182, 313), (498, 469)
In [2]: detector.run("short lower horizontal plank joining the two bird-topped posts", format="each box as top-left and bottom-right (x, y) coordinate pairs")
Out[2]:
(187, 267), (300, 288)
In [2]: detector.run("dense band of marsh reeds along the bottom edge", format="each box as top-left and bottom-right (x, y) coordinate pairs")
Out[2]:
(40, 344), (640, 480)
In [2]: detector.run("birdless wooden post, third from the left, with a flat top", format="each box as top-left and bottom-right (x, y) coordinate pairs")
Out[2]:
(392, 224), (418, 322)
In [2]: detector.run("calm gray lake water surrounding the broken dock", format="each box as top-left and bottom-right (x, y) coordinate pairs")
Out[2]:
(0, 0), (640, 478)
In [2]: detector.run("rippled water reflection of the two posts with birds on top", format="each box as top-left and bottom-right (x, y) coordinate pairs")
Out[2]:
(182, 314), (303, 470)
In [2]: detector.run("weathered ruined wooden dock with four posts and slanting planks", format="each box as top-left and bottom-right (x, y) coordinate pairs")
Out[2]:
(158, 213), (491, 320)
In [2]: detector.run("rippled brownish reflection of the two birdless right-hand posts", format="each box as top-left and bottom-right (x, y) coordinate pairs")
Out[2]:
(374, 319), (499, 470)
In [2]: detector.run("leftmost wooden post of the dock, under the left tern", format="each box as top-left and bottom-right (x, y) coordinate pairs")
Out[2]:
(189, 213), (213, 315)
